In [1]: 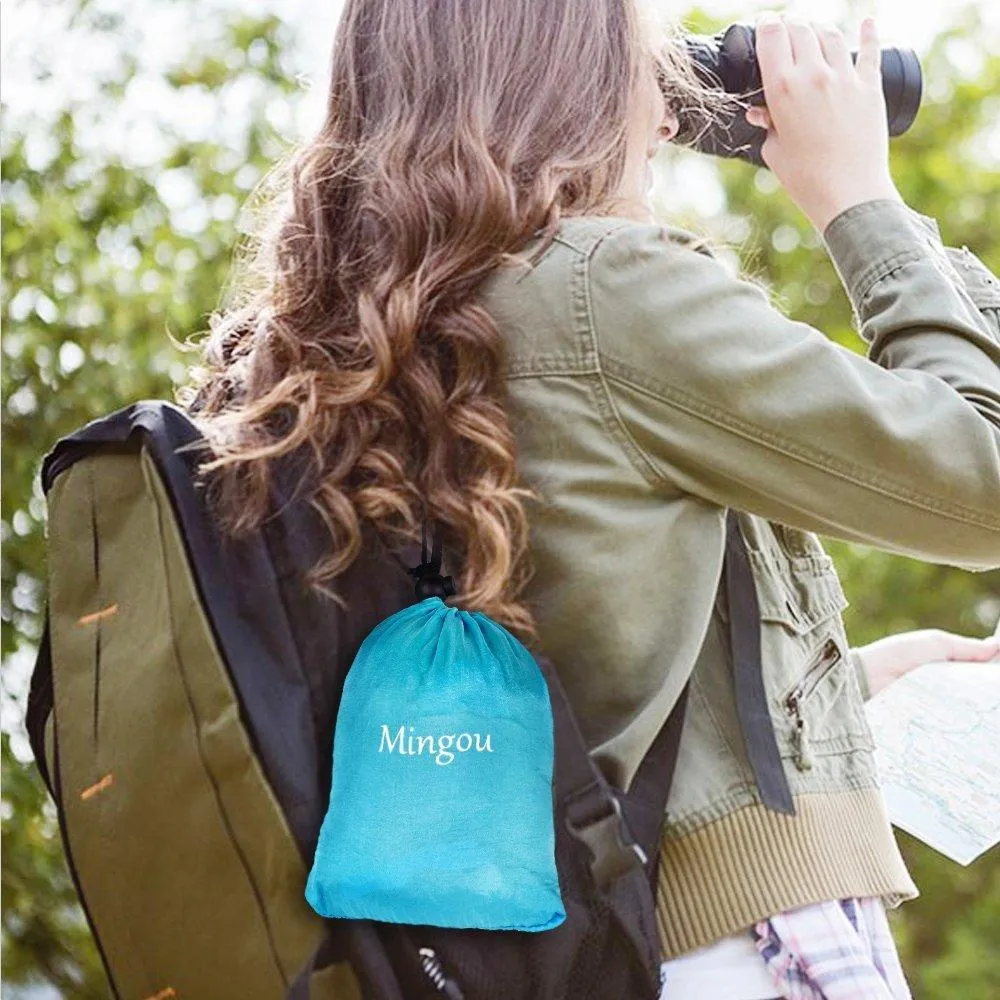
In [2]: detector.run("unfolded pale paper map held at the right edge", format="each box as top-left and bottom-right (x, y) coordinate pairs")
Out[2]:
(866, 661), (1000, 865)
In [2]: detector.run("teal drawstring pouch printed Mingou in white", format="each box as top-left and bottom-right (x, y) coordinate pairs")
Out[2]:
(306, 591), (566, 931)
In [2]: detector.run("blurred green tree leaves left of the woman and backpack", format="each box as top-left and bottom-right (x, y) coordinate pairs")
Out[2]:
(0, 3), (298, 1000)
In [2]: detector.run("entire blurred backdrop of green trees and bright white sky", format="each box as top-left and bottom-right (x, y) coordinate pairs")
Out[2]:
(0, 0), (1000, 1000)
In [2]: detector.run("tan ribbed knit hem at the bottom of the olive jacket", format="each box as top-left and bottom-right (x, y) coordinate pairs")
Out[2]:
(656, 789), (918, 959)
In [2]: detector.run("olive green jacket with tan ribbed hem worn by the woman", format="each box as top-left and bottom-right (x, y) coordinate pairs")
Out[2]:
(481, 199), (1000, 955)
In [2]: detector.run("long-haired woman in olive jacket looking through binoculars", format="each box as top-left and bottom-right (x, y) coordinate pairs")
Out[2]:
(182, 0), (1000, 1000)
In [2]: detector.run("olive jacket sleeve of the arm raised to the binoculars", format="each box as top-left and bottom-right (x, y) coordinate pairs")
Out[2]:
(587, 199), (1000, 570)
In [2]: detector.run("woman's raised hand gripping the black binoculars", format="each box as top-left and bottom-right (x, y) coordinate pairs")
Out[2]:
(746, 11), (902, 233)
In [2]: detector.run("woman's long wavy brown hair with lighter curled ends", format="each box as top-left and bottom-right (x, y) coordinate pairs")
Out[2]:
(178, 0), (728, 638)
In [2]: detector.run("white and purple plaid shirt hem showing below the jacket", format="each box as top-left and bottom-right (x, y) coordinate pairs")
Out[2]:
(752, 898), (911, 1000)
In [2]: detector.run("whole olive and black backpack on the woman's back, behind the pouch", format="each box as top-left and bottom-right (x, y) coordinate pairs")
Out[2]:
(27, 401), (780, 1000)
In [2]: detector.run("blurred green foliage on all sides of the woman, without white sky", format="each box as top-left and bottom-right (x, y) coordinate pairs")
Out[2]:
(0, 0), (1000, 1000)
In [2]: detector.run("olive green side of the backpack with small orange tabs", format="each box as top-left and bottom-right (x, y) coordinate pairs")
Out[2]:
(29, 404), (361, 1000)
